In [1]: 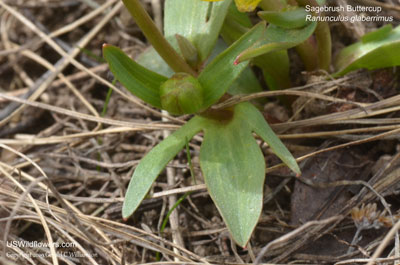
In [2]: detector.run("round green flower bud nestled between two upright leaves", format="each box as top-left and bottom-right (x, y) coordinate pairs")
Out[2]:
(160, 73), (203, 115)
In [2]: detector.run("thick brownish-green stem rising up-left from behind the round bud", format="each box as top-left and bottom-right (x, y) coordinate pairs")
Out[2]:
(123, 0), (197, 76)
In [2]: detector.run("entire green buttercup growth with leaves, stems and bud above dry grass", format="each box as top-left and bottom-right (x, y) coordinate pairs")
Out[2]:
(103, 0), (397, 246)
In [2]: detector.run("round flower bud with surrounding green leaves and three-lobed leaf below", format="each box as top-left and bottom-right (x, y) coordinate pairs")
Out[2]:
(103, 25), (300, 243)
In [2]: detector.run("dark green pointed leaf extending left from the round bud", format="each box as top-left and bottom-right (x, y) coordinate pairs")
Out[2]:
(103, 44), (167, 108)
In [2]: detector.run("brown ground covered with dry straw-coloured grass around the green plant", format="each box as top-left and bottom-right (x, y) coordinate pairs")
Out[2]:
(0, 0), (400, 264)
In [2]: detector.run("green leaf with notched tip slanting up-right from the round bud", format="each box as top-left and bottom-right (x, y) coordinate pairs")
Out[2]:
(198, 23), (265, 108)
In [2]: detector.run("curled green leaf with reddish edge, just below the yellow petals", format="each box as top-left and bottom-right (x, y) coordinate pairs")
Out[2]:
(236, 22), (317, 63)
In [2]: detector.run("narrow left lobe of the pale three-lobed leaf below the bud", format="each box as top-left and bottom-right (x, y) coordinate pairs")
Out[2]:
(122, 117), (203, 218)
